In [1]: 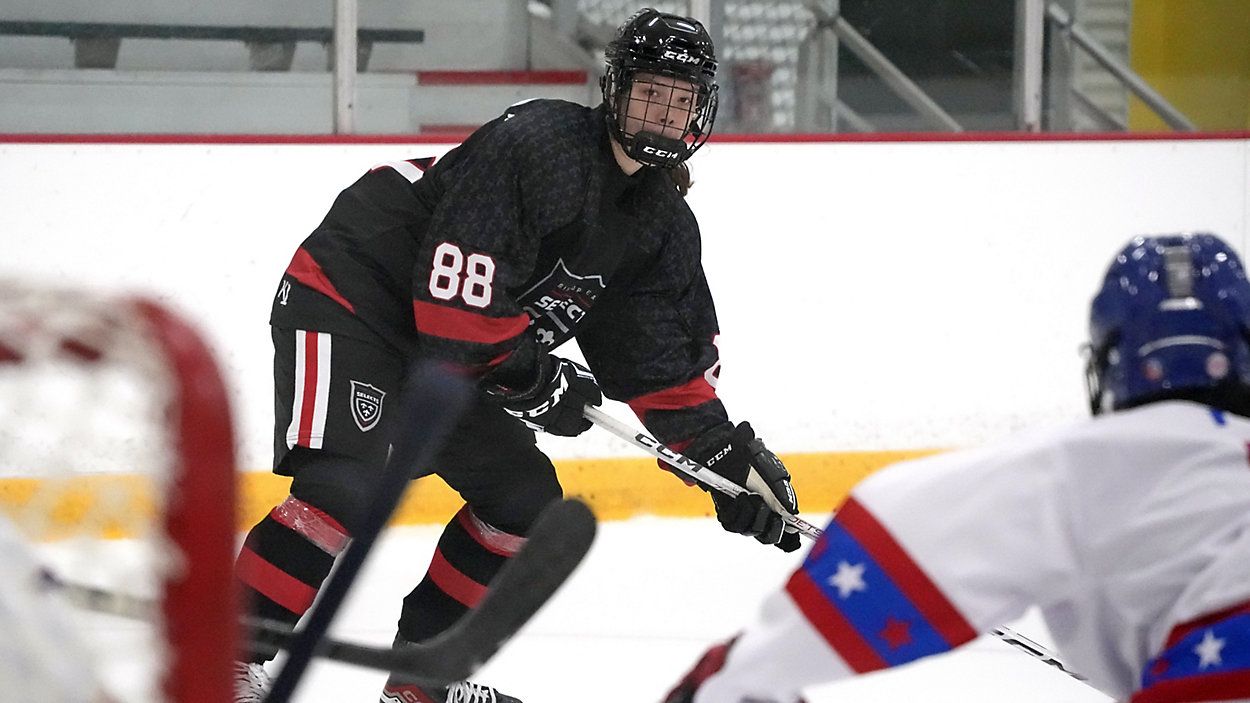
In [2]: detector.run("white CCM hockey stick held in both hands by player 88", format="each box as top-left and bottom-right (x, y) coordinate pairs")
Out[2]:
(583, 405), (1089, 683)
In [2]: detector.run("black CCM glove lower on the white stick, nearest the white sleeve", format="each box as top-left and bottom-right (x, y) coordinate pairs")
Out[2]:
(686, 423), (799, 552)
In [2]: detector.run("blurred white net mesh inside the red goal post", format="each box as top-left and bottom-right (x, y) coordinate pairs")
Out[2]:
(0, 283), (234, 700)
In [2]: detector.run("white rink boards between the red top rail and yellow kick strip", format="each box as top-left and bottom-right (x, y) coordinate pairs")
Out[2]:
(0, 135), (1250, 469)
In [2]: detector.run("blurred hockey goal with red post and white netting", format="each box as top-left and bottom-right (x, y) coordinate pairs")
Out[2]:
(0, 280), (238, 703)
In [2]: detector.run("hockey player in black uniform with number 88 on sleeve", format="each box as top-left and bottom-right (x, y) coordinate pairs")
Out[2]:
(238, 10), (799, 703)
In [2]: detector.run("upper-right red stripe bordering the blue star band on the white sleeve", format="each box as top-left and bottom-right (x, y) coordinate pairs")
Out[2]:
(835, 497), (976, 648)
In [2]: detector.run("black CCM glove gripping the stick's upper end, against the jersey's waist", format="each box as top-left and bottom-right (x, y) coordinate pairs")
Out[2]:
(501, 357), (604, 437)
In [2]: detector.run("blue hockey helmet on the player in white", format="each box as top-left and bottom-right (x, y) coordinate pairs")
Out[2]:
(1086, 234), (1250, 414)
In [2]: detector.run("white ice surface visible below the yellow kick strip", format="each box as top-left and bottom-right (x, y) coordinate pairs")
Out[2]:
(270, 515), (1110, 703)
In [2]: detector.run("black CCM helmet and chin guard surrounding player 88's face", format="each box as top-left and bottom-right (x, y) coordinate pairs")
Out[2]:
(599, 8), (716, 168)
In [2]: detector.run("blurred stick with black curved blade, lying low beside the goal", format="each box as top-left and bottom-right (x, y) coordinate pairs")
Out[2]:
(43, 499), (596, 687)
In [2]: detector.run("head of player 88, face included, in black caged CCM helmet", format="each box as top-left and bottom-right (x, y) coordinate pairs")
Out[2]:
(601, 9), (718, 168)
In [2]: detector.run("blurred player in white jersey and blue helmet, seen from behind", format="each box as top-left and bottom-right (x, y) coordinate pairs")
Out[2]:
(666, 235), (1250, 703)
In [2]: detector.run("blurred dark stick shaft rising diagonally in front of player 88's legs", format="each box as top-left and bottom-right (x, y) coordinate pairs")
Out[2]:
(265, 363), (471, 703)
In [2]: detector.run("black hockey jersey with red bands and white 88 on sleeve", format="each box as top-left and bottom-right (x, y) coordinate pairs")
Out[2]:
(271, 100), (728, 443)
